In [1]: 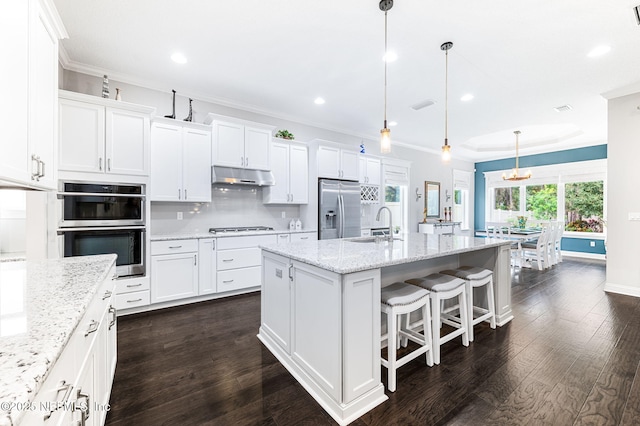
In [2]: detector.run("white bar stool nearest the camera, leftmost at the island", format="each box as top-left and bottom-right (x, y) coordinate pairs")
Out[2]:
(380, 282), (433, 392)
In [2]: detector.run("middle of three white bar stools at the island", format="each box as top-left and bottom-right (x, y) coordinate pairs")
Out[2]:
(405, 274), (469, 364)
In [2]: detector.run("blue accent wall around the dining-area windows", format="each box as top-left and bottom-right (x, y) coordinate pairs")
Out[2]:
(473, 145), (607, 254)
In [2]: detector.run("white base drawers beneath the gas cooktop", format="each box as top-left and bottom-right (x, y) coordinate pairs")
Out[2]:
(216, 235), (277, 293)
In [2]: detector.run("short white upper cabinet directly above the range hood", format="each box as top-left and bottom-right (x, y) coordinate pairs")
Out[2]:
(205, 114), (274, 170)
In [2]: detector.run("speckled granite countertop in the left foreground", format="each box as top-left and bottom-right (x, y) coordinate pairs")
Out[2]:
(0, 254), (116, 424)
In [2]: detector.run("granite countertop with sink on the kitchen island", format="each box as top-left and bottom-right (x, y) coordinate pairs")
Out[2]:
(260, 233), (511, 274)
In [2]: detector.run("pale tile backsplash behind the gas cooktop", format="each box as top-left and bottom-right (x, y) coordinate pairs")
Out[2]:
(150, 185), (302, 235)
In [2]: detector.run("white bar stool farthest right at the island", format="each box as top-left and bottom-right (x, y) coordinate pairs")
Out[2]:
(440, 266), (496, 342)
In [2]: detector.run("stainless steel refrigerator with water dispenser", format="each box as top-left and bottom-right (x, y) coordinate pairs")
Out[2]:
(318, 179), (360, 240)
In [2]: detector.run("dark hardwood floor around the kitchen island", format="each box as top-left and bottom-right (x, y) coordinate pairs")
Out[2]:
(107, 258), (640, 426)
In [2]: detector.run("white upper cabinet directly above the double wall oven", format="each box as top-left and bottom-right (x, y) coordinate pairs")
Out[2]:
(59, 90), (154, 176)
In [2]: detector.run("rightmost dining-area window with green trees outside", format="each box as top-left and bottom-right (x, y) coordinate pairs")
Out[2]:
(564, 181), (604, 232)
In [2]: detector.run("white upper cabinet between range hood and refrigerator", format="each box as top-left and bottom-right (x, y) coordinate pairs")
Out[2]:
(262, 139), (309, 204)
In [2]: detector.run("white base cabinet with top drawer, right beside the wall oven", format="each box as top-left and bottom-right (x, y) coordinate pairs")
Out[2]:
(151, 240), (198, 303)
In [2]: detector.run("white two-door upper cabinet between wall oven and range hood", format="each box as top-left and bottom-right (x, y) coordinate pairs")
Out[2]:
(150, 119), (211, 202)
